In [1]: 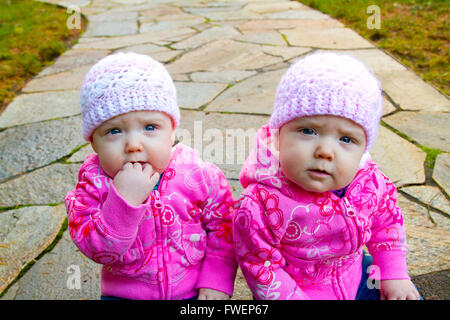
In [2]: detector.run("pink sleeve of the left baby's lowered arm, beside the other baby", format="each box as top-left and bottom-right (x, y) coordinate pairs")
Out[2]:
(196, 164), (237, 296)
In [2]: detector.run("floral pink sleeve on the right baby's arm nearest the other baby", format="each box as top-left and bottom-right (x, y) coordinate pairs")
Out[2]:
(233, 186), (309, 300)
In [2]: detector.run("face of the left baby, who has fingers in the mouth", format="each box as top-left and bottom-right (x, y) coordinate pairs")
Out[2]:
(92, 111), (175, 178)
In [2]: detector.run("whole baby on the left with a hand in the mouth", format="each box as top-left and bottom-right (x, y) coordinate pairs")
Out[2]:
(65, 53), (237, 300)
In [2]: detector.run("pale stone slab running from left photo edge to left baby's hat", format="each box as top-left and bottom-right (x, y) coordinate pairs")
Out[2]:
(0, 90), (80, 128)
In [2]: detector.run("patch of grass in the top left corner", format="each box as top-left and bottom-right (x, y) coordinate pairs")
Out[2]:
(0, 0), (85, 113)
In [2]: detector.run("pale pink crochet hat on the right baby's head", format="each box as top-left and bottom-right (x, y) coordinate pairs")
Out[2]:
(269, 52), (383, 151)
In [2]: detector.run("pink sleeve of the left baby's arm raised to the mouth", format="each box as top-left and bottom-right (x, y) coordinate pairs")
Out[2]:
(64, 165), (149, 265)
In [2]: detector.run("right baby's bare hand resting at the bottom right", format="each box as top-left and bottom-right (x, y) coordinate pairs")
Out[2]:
(380, 279), (420, 300)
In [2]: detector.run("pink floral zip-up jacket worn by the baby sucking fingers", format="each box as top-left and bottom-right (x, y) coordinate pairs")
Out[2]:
(65, 143), (237, 300)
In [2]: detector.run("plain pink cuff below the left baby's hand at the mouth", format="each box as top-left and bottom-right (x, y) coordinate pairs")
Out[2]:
(102, 183), (150, 238)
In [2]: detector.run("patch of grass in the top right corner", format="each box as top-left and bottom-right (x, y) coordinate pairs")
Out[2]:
(297, 0), (450, 96)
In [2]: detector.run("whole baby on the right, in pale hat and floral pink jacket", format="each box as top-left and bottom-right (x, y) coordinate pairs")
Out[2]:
(233, 53), (420, 299)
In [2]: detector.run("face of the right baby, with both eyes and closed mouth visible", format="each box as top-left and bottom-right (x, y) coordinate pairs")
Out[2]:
(276, 115), (366, 192)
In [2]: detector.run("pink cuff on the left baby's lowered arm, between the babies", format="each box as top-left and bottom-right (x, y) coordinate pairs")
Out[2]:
(196, 256), (237, 297)
